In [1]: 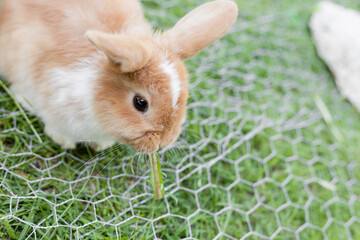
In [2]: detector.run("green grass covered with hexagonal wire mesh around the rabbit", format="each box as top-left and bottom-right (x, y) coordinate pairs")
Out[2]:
(0, 0), (360, 240)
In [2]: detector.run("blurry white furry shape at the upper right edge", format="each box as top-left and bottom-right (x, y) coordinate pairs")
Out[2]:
(310, 1), (360, 111)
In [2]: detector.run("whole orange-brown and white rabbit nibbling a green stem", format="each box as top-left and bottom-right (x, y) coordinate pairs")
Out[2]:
(0, 0), (237, 152)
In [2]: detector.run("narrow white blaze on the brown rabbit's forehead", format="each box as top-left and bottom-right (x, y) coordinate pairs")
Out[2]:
(160, 60), (181, 108)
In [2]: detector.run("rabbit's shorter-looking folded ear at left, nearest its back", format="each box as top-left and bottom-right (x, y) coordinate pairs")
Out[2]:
(85, 31), (150, 72)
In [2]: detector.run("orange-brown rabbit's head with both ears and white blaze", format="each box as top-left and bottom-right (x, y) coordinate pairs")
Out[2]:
(86, 0), (237, 152)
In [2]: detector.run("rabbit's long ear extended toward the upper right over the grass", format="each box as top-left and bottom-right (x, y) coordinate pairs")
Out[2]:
(162, 0), (238, 59)
